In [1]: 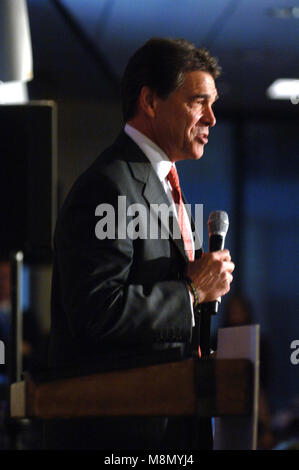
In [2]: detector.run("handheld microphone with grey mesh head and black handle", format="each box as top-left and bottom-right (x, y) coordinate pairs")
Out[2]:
(199, 211), (229, 358)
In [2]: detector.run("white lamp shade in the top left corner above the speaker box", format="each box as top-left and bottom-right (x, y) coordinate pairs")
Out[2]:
(0, 0), (33, 82)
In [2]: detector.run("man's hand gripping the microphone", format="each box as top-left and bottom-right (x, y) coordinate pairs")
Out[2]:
(187, 250), (235, 303)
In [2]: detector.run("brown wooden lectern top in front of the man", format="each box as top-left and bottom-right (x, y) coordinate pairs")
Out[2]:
(11, 327), (257, 449)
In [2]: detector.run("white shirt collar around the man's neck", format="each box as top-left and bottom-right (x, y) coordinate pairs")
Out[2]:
(124, 124), (174, 181)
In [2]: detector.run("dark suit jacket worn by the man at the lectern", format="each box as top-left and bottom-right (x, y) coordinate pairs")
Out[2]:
(45, 132), (213, 445)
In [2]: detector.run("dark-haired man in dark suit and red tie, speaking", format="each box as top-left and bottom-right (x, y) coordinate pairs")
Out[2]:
(47, 39), (234, 449)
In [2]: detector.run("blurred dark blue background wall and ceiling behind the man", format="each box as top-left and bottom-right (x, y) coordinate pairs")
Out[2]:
(0, 0), (299, 448)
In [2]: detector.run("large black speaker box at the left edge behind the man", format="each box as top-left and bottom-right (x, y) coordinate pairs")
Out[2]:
(0, 101), (57, 263)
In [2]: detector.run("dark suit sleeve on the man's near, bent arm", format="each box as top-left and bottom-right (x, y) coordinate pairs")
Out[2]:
(55, 171), (192, 345)
